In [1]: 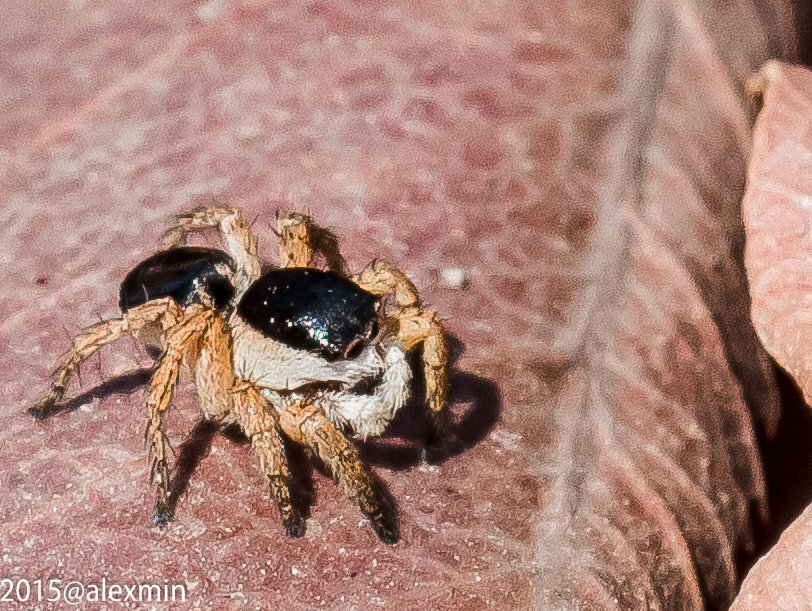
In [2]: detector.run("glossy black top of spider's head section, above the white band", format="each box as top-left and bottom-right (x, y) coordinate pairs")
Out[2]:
(237, 267), (377, 360)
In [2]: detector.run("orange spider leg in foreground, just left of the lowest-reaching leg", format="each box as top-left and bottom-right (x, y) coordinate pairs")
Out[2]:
(231, 380), (305, 537)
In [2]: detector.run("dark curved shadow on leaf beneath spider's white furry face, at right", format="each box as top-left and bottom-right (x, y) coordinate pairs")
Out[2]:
(359, 335), (502, 471)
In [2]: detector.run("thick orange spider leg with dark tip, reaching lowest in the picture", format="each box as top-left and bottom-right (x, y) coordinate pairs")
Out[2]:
(279, 401), (398, 543)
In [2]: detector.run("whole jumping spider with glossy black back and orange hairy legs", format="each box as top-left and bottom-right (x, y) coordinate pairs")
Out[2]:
(29, 205), (447, 543)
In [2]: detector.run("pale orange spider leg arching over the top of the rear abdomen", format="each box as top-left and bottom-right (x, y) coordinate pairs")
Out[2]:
(163, 204), (262, 294)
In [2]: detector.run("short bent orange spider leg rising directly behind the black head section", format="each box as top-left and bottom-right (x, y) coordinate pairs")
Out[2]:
(276, 212), (346, 274)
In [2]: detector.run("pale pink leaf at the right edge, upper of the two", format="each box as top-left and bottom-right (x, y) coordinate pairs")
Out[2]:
(742, 62), (812, 402)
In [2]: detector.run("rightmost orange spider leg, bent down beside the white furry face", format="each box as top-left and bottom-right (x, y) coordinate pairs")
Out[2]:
(351, 261), (448, 445)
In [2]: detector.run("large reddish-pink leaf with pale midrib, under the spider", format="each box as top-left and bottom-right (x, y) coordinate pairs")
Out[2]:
(0, 0), (793, 609)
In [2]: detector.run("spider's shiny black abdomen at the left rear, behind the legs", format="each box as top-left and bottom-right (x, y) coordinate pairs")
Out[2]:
(119, 246), (234, 312)
